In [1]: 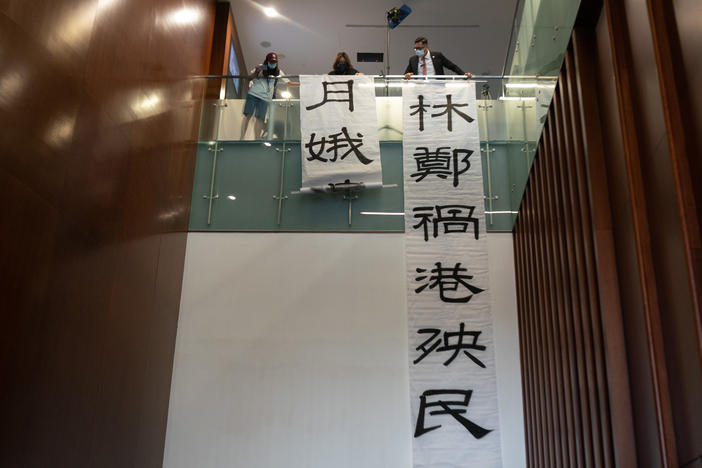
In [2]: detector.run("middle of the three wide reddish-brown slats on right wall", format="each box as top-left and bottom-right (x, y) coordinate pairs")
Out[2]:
(604, 0), (678, 468)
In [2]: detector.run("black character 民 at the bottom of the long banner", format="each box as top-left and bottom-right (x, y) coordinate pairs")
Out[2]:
(414, 390), (492, 439)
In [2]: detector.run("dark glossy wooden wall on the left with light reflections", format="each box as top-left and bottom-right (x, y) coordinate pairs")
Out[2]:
(0, 0), (214, 468)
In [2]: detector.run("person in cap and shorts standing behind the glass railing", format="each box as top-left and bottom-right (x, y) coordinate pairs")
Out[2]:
(241, 52), (287, 140)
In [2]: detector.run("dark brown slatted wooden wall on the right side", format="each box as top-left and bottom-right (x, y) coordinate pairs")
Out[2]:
(514, 0), (702, 467)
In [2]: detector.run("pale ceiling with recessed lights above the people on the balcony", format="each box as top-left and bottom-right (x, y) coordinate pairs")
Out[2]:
(230, 0), (518, 75)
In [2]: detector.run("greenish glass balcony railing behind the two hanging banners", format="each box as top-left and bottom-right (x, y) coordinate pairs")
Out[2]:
(190, 76), (554, 232)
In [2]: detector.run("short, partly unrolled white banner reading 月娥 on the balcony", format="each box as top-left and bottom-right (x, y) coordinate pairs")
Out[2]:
(300, 75), (383, 189)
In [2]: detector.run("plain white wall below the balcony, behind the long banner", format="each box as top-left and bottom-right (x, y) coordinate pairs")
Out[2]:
(164, 233), (525, 468)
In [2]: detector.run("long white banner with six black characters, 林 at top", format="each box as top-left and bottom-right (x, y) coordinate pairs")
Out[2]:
(402, 82), (502, 468)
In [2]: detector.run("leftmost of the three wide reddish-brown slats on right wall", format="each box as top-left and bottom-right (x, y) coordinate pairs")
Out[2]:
(566, 28), (638, 467)
